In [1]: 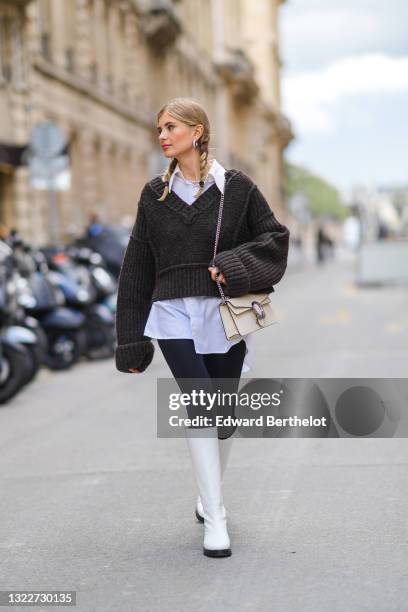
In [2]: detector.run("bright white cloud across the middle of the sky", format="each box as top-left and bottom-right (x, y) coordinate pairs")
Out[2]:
(282, 53), (408, 134)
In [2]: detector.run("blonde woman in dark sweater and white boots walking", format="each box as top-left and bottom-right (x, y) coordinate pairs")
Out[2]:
(115, 98), (289, 557)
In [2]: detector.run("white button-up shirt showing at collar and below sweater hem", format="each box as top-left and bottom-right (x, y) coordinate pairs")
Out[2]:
(144, 159), (252, 372)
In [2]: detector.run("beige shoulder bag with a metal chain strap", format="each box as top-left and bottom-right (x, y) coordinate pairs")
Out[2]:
(212, 188), (277, 340)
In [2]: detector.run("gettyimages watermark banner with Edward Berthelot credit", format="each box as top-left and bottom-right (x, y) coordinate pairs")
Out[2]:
(157, 378), (408, 438)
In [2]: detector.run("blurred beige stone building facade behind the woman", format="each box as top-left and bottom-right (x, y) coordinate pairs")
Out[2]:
(0, 0), (293, 244)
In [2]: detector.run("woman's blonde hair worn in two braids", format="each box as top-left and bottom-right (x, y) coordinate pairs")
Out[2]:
(157, 98), (210, 202)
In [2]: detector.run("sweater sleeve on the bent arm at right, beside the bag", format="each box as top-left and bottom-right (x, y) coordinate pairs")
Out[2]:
(210, 185), (289, 297)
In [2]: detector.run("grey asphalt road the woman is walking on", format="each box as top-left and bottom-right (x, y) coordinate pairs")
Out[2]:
(0, 262), (408, 612)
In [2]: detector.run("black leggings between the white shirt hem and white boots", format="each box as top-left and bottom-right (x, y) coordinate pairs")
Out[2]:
(157, 338), (246, 439)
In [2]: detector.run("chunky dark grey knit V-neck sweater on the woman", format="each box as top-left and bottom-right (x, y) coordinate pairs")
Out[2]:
(115, 170), (289, 372)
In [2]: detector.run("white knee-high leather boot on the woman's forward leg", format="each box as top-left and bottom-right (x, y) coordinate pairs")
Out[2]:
(186, 427), (231, 557)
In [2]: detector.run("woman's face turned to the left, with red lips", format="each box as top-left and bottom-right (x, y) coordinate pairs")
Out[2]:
(157, 111), (202, 157)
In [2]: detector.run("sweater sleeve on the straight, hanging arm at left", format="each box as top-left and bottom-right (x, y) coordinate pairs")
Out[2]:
(115, 202), (155, 373)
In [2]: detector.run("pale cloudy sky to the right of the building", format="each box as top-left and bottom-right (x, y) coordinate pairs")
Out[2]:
(279, 0), (408, 193)
